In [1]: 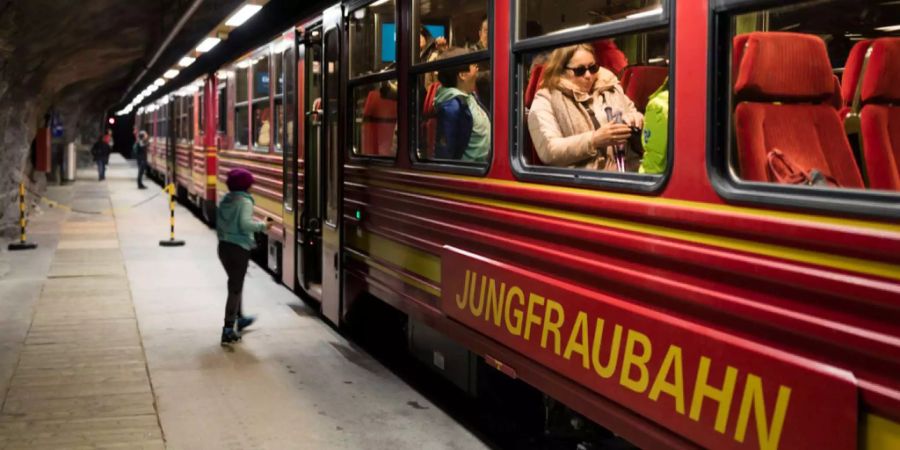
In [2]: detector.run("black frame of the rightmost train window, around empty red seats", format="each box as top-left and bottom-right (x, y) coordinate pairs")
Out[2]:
(706, 0), (900, 219)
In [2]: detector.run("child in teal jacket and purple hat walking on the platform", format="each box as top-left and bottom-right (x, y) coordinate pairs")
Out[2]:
(216, 169), (272, 345)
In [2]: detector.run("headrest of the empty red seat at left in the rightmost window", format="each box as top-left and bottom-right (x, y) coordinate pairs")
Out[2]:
(734, 32), (834, 101)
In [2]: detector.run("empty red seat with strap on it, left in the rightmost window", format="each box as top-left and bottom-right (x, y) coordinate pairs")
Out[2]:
(734, 32), (863, 188)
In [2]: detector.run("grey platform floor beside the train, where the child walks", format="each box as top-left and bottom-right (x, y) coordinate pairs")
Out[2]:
(0, 155), (486, 449)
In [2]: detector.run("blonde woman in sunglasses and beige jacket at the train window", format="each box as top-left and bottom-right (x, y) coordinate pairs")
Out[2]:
(528, 44), (644, 172)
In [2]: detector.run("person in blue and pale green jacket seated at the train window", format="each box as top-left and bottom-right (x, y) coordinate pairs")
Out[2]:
(434, 49), (491, 162)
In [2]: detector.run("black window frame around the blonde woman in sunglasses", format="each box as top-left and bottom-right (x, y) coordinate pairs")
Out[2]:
(507, 0), (677, 195)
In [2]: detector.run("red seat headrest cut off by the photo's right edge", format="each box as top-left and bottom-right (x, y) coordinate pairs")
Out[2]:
(860, 38), (900, 103)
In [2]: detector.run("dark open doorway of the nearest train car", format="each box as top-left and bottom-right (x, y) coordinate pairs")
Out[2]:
(292, 25), (324, 301)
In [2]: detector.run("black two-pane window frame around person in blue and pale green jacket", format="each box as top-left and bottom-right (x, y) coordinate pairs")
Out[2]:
(403, 0), (492, 177)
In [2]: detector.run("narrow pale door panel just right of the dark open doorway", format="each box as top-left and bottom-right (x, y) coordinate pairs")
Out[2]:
(319, 5), (343, 325)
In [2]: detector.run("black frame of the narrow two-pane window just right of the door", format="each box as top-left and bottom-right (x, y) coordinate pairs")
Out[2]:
(346, 0), (405, 166)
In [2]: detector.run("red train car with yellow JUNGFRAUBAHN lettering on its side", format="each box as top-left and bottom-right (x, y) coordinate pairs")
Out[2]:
(141, 0), (900, 449)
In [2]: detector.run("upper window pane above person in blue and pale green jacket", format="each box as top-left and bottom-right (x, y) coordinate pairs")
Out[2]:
(412, 0), (489, 63)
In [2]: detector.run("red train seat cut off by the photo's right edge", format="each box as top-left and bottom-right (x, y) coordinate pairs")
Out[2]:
(857, 38), (900, 191)
